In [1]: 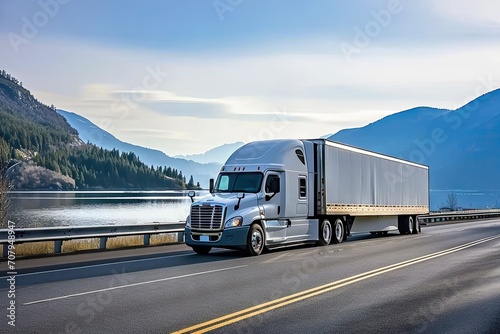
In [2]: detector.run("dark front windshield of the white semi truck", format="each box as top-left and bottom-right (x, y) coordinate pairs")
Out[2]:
(214, 172), (263, 193)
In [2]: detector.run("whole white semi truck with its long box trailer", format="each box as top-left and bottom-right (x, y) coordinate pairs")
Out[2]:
(185, 139), (429, 255)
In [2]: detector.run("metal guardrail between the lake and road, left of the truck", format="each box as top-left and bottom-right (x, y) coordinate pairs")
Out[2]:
(0, 223), (185, 257)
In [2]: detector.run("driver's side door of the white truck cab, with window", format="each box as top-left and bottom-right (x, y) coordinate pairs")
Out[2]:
(259, 172), (289, 245)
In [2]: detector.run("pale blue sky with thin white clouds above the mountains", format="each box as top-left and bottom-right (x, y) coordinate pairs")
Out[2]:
(0, 0), (500, 156)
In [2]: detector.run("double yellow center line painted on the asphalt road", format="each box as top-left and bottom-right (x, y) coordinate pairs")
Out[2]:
(174, 235), (500, 334)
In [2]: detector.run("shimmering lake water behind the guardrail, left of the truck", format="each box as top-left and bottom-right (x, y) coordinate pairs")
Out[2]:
(8, 190), (205, 227)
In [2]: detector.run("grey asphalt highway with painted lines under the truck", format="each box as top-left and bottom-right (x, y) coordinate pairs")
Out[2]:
(0, 219), (500, 333)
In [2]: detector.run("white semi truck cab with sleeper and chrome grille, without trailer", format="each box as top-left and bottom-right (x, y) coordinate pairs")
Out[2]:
(185, 140), (317, 255)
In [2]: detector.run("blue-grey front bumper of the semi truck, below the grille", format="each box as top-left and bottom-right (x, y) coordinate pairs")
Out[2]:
(184, 226), (250, 249)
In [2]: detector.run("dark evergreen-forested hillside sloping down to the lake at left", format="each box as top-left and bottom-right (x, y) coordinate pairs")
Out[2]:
(0, 70), (196, 189)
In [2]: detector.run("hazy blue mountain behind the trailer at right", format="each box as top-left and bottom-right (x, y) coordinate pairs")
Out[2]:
(329, 89), (500, 207)
